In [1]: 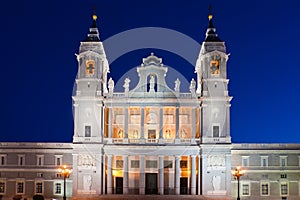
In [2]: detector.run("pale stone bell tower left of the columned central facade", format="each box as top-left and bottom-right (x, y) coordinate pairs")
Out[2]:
(72, 14), (109, 196)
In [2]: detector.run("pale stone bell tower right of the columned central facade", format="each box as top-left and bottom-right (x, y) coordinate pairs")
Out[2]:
(195, 10), (232, 197)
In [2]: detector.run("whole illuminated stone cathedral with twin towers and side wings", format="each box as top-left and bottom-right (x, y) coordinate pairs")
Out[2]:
(0, 12), (300, 200)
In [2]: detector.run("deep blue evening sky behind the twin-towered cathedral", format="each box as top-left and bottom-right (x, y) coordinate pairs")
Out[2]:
(0, 0), (300, 143)
